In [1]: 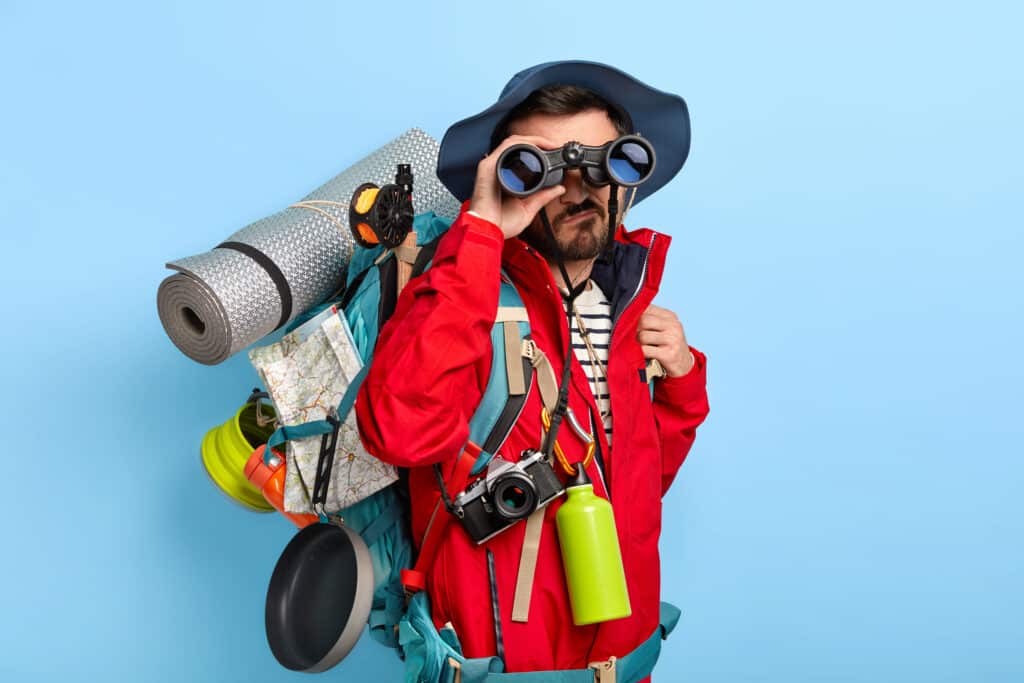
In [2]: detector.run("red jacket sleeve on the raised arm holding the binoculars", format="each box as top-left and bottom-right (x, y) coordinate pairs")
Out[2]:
(355, 206), (505, 467)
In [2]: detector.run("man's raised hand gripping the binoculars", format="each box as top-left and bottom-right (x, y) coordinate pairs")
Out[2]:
(469, 135), (565, 240)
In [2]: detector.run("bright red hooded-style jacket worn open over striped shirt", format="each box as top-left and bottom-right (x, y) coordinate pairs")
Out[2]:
(355, 208), (708, 672)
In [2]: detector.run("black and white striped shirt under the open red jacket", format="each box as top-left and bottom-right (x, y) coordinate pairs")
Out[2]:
(563, 280), (611, 445)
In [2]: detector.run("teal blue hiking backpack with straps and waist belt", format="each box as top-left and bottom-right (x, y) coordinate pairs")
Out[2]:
(266, 213), (679, 683)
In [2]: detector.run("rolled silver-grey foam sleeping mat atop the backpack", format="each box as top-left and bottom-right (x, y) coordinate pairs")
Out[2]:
(157, 128), (459, 366)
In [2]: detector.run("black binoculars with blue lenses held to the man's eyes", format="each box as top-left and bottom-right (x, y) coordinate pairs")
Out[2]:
(498, 135), (654, 197)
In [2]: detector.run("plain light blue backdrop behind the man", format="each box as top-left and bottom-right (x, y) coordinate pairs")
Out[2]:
(0, 0), (1024, 683)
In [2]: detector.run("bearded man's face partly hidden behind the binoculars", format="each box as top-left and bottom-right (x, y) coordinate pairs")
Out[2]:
(509, 110), (622, 261)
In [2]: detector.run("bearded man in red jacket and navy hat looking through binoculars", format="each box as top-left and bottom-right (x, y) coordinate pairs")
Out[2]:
(356, 61), (708, 680)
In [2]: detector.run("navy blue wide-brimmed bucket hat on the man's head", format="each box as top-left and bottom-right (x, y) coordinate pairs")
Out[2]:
(437, 60), (690, 202)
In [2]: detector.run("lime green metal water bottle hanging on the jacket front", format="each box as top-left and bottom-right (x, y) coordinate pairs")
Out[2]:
(555, 465), (633, 626)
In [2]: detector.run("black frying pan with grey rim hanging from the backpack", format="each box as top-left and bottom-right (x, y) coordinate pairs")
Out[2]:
(266, 523), (374, 674)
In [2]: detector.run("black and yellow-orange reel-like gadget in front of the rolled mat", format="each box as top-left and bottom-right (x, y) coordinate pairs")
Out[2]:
(348, 164), (414, 249)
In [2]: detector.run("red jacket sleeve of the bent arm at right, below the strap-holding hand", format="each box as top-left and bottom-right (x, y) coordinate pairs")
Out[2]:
(654, 346), (709, 496)
